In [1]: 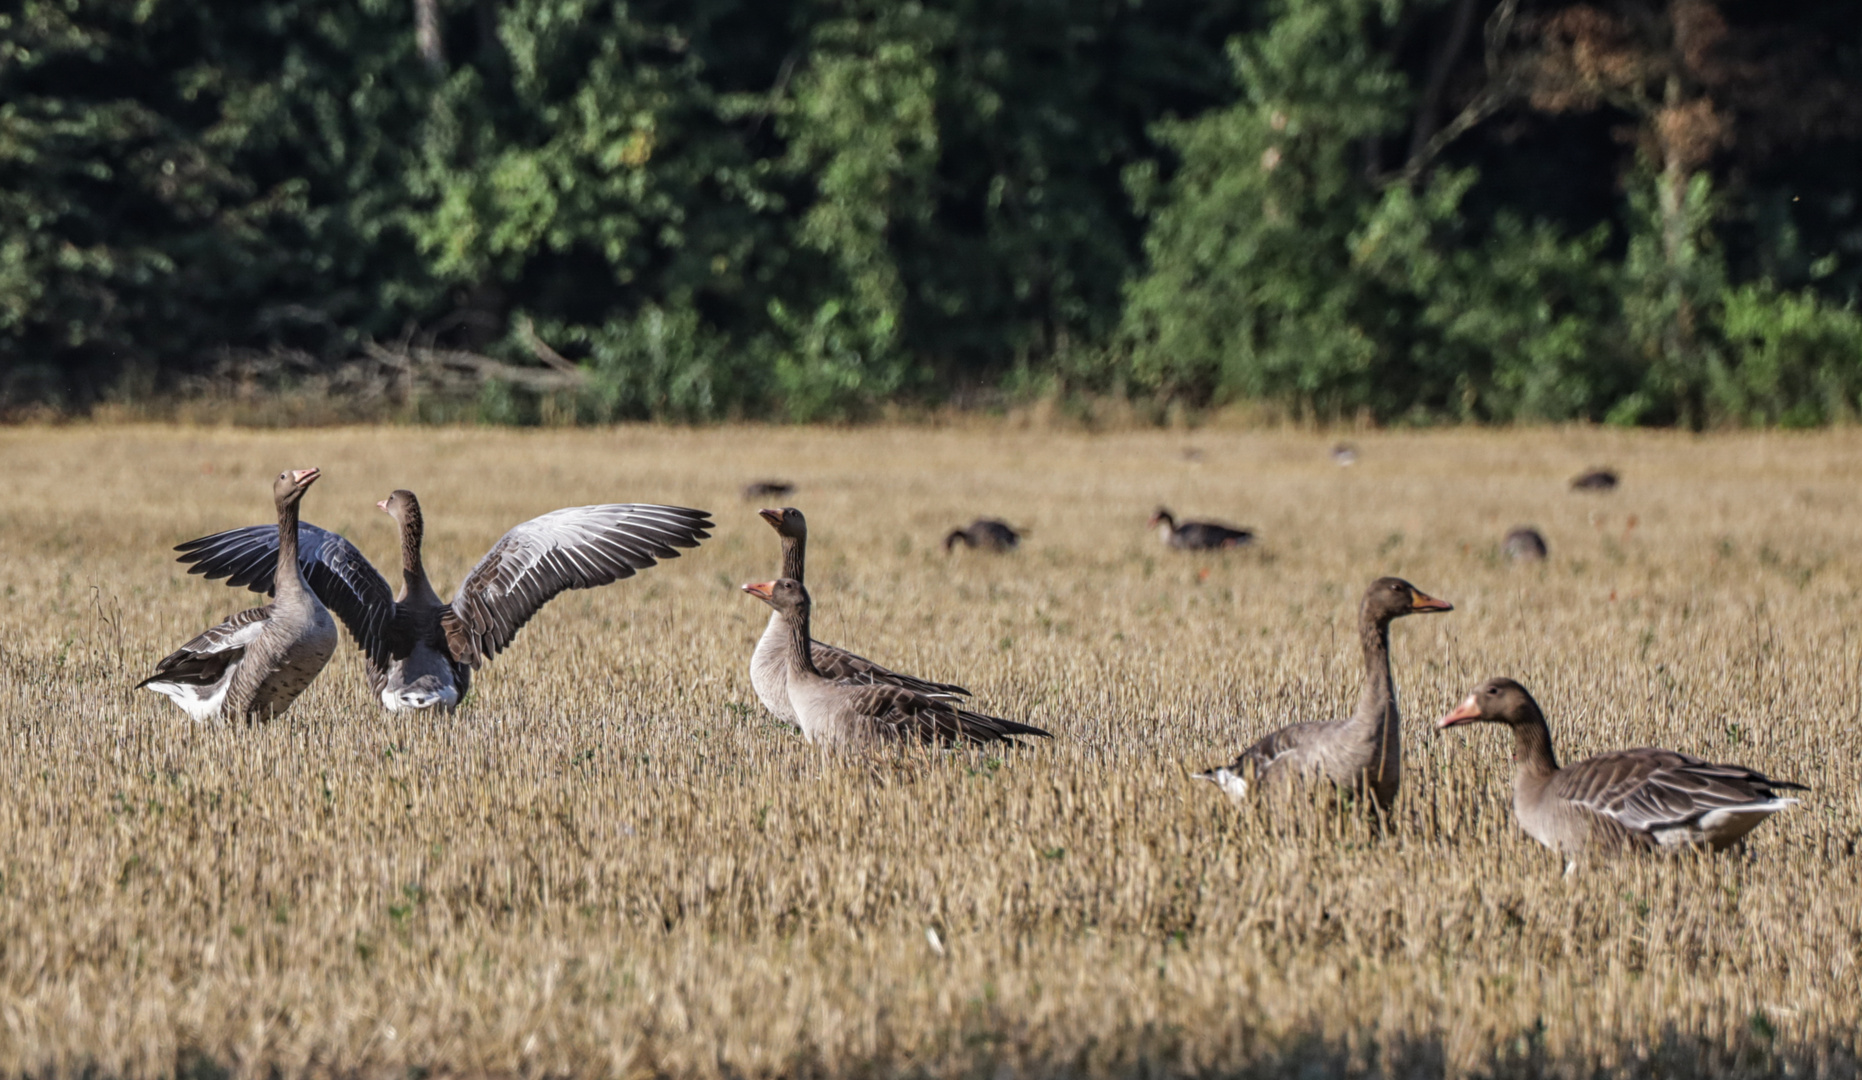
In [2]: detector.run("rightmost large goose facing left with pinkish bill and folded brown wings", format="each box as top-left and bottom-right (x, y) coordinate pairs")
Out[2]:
(1439, 678), (1806, 870)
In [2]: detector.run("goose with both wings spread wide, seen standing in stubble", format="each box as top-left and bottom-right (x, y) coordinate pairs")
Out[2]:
(177, 490), (711, 713)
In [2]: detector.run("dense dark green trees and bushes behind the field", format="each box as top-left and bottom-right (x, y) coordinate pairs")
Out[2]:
(0, 0), (1862, 425)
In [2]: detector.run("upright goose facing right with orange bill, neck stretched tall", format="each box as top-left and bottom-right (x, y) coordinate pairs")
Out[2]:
(1197, 577), (1454, 810)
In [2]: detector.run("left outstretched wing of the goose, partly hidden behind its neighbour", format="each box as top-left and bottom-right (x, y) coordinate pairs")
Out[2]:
(175, 521), (395, 667)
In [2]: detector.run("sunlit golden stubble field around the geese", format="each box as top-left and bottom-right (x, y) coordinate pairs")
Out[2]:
(0, 426), (1862, 1080)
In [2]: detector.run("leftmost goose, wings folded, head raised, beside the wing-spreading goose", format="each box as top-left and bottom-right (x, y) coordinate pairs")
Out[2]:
(136, 469), (337, 721)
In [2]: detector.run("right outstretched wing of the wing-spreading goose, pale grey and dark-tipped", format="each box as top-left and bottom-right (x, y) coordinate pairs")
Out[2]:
(441, 503), (713, 667)
